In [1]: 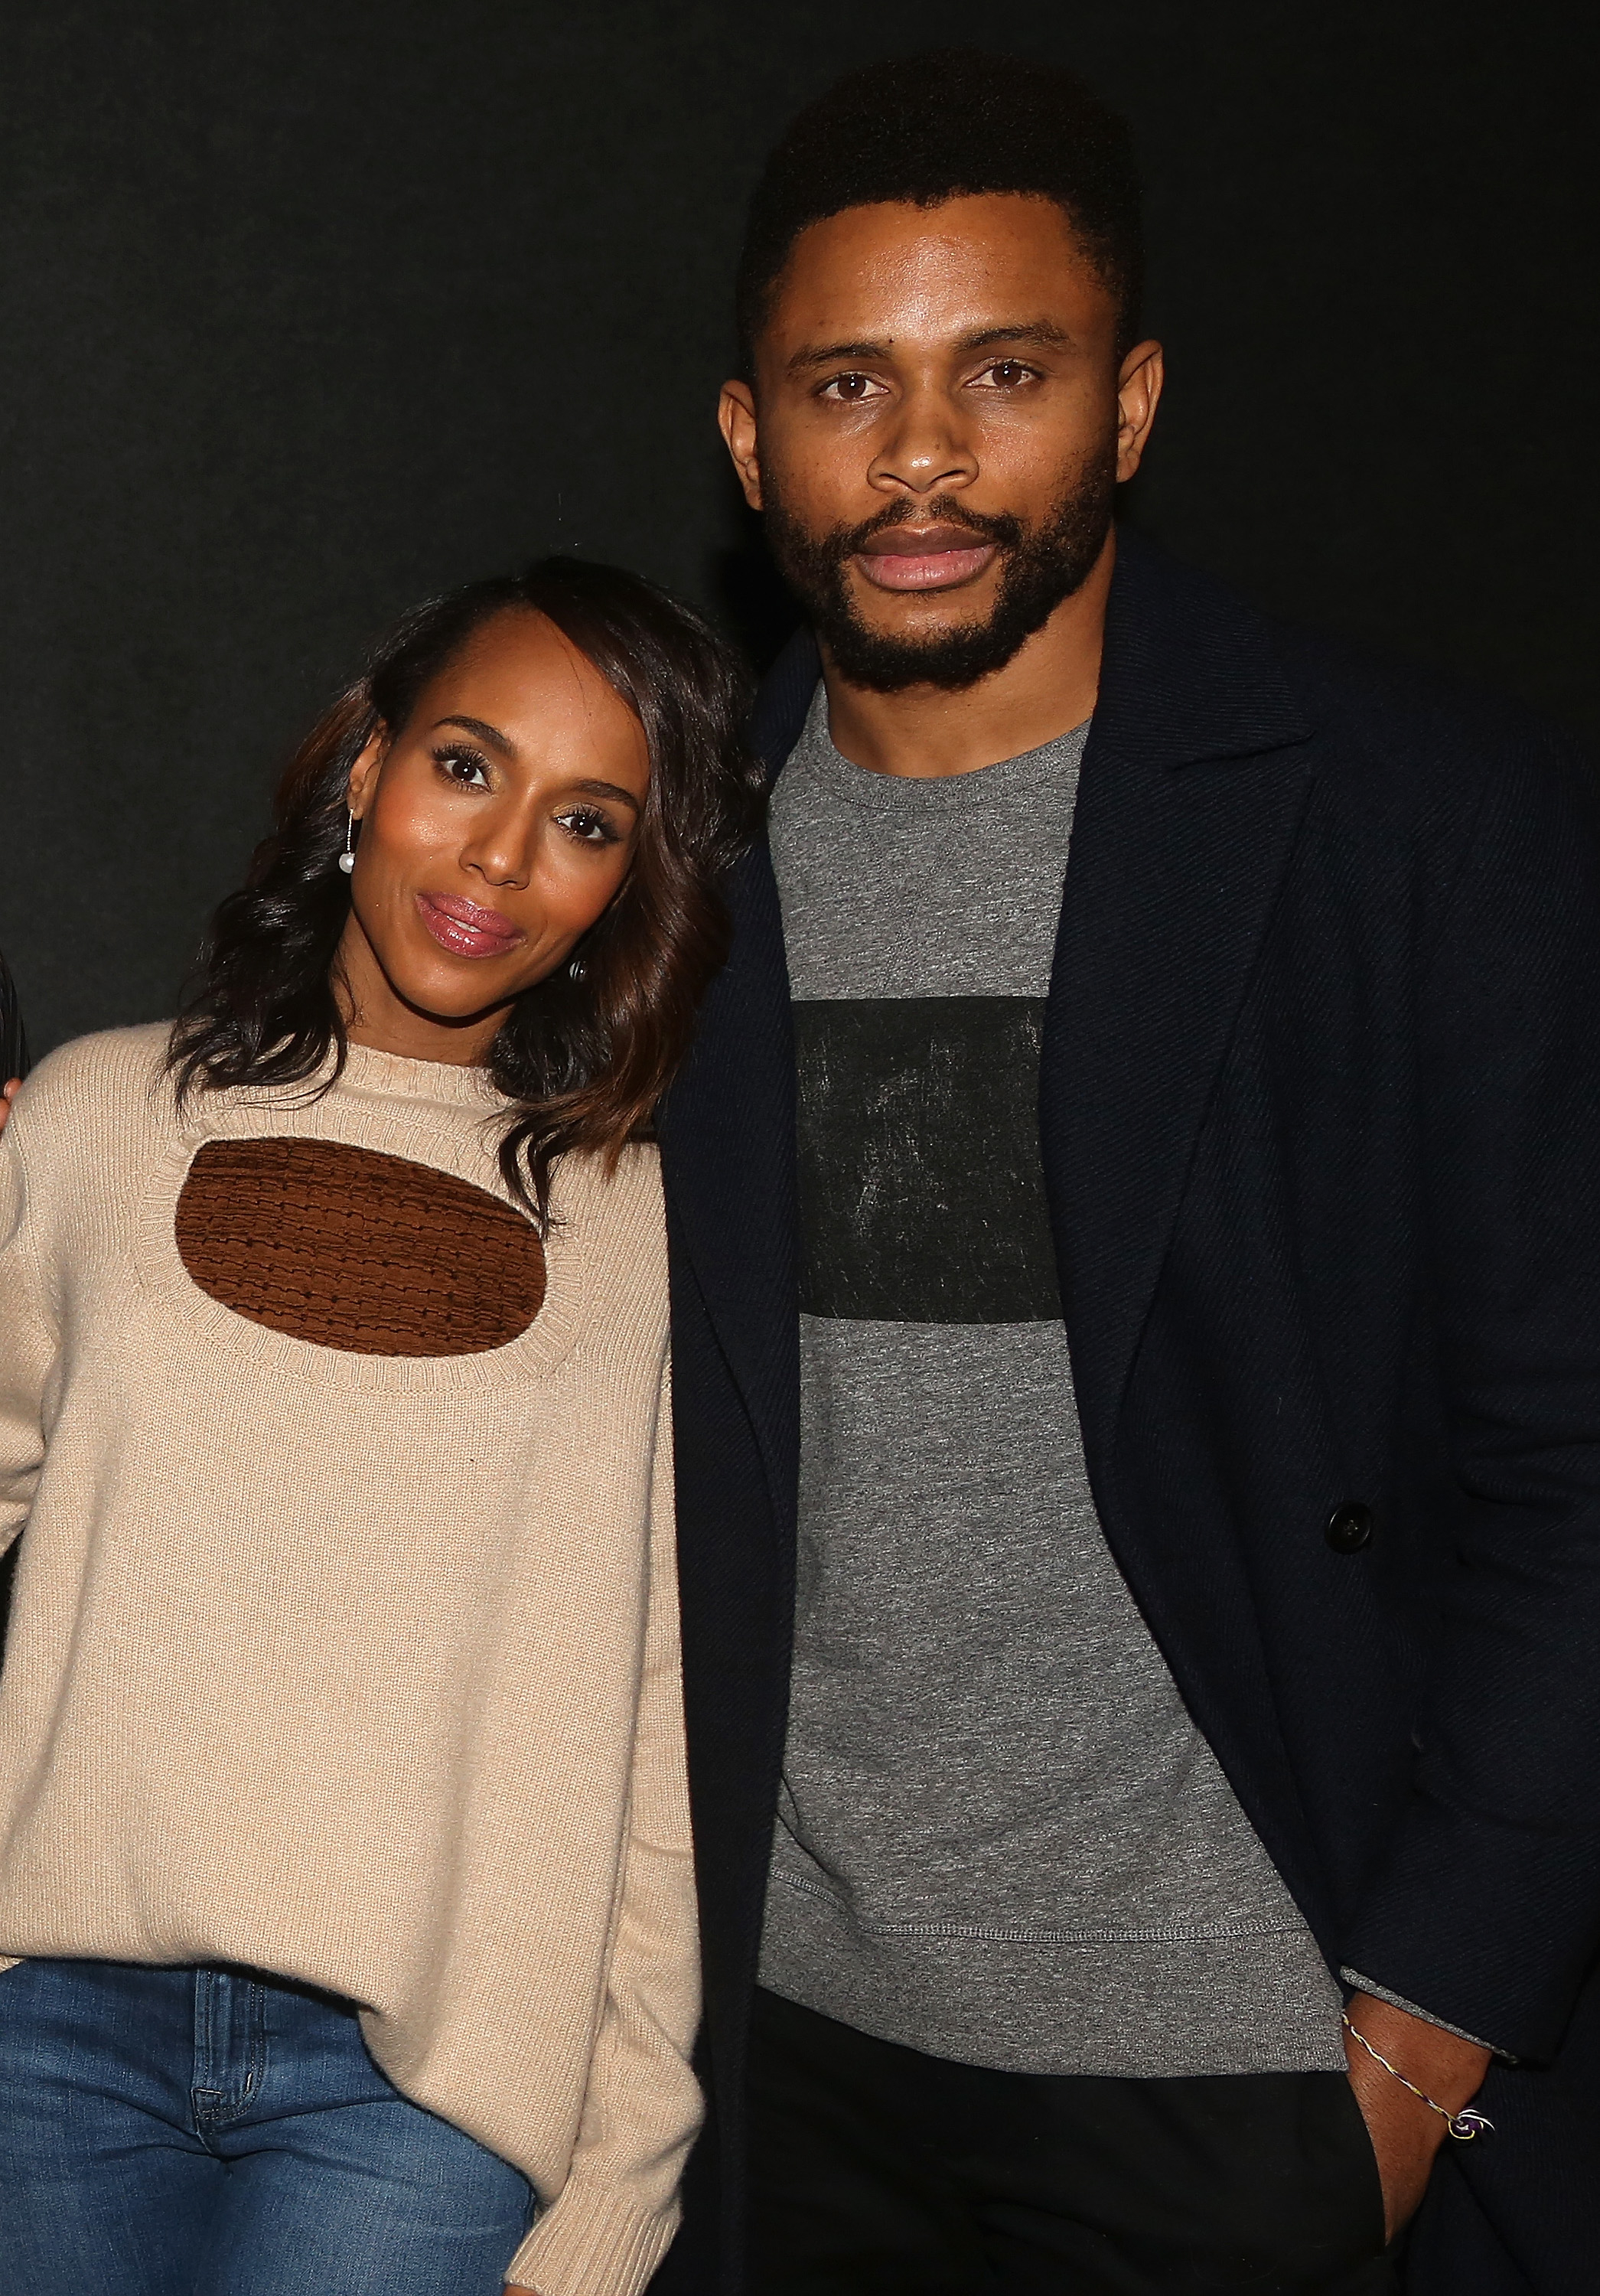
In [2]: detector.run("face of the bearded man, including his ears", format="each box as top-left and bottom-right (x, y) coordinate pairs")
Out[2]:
(723, 193), (1159, 691)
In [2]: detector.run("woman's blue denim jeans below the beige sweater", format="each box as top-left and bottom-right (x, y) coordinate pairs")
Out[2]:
(0, 1961), (535, 2296)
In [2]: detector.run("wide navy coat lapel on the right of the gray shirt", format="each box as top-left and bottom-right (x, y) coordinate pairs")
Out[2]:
(1040, 537), (1311, 1465)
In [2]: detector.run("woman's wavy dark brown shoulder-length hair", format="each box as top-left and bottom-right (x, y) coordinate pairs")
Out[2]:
(168, 558), (762, 1226)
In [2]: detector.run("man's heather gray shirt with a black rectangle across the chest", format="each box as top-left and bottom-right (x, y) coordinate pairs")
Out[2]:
(762, 691), (1345, 2076)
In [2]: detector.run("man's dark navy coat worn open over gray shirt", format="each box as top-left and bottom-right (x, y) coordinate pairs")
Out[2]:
(661, 537), (1600, 2296)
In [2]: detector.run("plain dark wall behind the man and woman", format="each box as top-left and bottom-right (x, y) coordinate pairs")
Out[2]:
(0, 0), (1600, 1049)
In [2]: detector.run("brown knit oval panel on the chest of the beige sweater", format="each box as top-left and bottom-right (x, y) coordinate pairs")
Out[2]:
(174, 1139), (544, 1355)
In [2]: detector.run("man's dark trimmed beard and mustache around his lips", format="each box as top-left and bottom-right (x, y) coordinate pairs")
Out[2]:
(767, 443), (1116, 693)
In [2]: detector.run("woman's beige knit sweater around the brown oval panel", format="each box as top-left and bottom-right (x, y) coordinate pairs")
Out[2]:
(0, 1029), (700, 2296)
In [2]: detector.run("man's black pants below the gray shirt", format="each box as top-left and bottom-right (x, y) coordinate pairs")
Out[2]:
(751, 1993), (1396, 2296)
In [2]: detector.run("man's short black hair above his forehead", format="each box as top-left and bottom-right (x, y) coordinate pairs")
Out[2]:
(737, 48), (1143, 377)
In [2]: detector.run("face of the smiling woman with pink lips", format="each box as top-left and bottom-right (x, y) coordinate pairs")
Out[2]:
(335, 606), (650, 1063)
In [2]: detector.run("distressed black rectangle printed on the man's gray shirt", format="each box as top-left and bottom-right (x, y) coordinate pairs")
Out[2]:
(794, 996), (1061, 1322)
